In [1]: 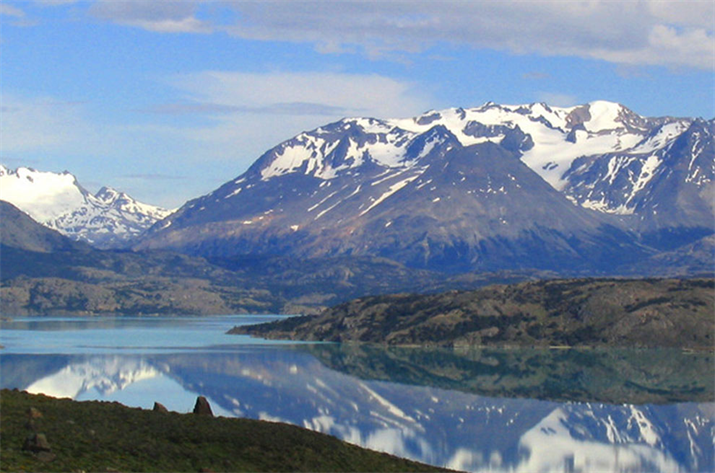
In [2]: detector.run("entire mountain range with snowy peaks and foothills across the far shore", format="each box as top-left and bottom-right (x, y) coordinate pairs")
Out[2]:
(0, 102), (715, 314)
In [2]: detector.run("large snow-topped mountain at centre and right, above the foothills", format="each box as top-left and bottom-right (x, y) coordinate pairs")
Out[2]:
(137, 101), (715, 271)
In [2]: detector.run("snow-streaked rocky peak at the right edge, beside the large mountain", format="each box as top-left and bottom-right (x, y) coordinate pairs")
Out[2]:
(563, 120), (715, 228)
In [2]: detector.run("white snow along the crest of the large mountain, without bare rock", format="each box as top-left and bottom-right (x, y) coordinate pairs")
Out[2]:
(261, 101), (689, 190)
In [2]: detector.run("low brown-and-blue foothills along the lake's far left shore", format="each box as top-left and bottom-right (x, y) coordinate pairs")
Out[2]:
(0, 197), (535, 316)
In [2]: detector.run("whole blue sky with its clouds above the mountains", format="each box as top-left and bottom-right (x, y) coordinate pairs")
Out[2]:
(0, 0), (715, 207)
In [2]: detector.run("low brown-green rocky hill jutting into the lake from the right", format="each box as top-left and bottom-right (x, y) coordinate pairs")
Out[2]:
(231, 279), (715, 350)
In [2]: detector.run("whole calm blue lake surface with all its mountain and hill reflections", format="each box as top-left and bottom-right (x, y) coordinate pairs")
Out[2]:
(0, 316), (715, 473)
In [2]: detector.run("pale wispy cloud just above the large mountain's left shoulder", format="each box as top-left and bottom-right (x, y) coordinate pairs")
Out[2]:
(161, 71), (428, 167)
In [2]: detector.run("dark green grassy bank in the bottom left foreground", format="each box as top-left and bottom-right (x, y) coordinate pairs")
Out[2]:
(0, 390), (445, 473)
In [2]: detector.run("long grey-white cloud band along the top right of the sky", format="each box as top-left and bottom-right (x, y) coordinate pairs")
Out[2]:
(217, 0), (715, 69)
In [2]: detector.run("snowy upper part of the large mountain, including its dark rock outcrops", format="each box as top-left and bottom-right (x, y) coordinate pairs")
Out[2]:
(246, 101), (692, 214)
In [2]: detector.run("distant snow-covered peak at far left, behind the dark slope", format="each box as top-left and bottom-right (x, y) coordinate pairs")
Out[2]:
(0, 165), (170, 248)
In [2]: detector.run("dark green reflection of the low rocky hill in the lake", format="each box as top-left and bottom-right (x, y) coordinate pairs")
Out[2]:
(301, 343), (715, 404)
